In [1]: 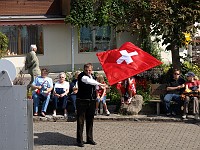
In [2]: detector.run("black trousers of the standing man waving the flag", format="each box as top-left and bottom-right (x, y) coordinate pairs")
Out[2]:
(76, 99), (95, 143)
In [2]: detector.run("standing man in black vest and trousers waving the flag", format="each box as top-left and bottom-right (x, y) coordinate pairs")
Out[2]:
(76, 63), (106, 147)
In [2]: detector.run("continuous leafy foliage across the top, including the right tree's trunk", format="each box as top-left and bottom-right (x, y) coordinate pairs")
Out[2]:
(66, 0), (200, 68)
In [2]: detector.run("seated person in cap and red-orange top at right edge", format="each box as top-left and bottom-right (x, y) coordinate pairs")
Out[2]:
(182, 72), (200, 119)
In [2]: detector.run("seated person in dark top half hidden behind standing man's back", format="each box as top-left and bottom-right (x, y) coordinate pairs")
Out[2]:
(69, 71), (80, 113)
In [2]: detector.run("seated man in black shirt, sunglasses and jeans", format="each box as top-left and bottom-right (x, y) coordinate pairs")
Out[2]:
(164, 69), (185, 116)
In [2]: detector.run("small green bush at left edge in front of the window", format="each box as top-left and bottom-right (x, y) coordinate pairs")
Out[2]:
(0, 32), (8, 58)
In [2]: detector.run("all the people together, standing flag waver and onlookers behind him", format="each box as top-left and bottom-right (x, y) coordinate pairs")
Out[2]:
(25, 45), (200, 147)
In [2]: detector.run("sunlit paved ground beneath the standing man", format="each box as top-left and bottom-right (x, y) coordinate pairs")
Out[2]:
(34, 119), (200, 150)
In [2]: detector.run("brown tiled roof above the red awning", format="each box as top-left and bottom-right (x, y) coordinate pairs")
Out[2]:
(0, 0), (62, 15)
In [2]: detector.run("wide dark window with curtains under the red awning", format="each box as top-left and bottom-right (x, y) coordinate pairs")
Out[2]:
(0, 26), (44, 56)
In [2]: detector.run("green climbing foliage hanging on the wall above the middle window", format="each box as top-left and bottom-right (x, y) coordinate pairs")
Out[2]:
(65, 0), (132, 27)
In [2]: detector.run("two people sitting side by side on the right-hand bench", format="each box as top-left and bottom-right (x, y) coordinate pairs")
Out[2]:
(164, 69), (200, 119)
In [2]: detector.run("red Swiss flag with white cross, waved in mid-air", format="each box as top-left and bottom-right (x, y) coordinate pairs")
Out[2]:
(96, 42), (162, 85)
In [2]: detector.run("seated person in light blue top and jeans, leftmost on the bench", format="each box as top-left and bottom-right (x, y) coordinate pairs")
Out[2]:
(31, 68), (53, 117)
